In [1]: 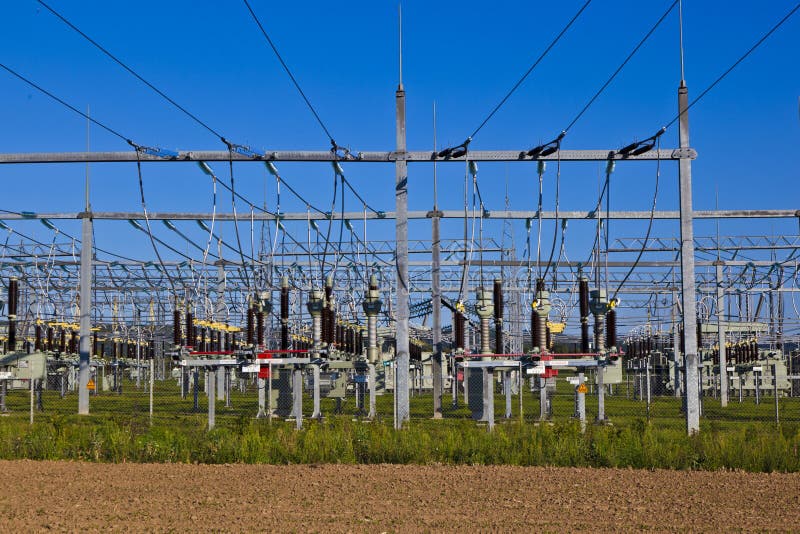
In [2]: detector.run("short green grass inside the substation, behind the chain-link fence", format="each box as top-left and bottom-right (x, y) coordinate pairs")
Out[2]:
(6, 372), (800, 430)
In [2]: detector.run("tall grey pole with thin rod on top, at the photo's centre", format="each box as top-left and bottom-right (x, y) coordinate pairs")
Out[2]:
(394, 5), (410, 428)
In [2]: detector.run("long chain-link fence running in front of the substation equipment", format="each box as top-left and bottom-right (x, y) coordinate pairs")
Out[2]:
(0, 354), (800, 434)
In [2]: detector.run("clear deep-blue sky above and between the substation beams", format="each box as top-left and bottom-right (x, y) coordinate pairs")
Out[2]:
(0, 0), (800, 330)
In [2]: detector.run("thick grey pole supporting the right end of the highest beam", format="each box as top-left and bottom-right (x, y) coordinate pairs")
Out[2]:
(678, 84), (700, 434)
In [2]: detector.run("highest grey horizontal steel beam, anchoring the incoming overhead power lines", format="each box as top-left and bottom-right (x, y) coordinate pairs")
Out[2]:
(0, 149), (697, 163)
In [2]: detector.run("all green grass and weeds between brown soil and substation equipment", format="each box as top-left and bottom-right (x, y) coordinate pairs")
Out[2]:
(0, 374), (800, 471)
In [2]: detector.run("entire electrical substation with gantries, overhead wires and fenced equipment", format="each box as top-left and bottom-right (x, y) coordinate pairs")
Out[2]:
(0, 1), (800, 433)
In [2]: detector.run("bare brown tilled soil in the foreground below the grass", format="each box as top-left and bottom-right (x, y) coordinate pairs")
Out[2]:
(0, 461), (800, 532)
